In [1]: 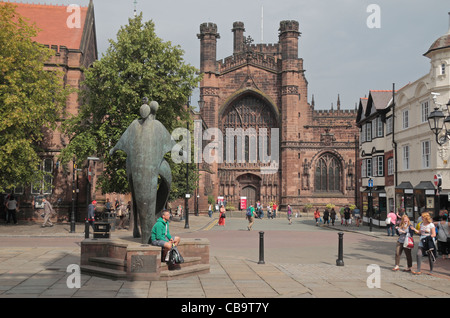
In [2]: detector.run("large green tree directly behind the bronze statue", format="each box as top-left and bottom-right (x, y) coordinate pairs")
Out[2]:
(61, 14), (200, 198)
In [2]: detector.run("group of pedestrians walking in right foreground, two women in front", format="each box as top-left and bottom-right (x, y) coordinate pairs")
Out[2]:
(388, 212), (450, 275)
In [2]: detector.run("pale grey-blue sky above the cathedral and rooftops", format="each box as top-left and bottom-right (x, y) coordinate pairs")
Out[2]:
(12, 0), (450, 109)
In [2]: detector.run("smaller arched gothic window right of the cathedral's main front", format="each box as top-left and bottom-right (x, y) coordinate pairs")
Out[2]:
(314, 154), (342, 192)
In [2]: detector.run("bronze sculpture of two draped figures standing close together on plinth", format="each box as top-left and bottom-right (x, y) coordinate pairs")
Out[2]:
(109, 98), (175, 244)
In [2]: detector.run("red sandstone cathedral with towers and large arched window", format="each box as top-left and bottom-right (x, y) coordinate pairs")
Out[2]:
(197, 21), (359, 211)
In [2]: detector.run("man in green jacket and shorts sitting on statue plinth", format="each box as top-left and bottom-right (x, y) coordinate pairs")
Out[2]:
(150, 210), (180, 262)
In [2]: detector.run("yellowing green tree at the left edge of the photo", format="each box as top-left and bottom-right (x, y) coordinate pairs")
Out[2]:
(0, 3), (68, 192)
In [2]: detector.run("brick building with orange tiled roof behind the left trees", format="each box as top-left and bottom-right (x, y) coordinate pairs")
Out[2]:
(0, 1), (97, 220)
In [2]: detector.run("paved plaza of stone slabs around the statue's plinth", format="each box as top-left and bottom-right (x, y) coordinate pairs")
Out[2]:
(0, 215), (450, 299)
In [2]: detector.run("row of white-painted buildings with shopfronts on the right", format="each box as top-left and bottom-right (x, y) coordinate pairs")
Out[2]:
(357, 13), (450, 225)
